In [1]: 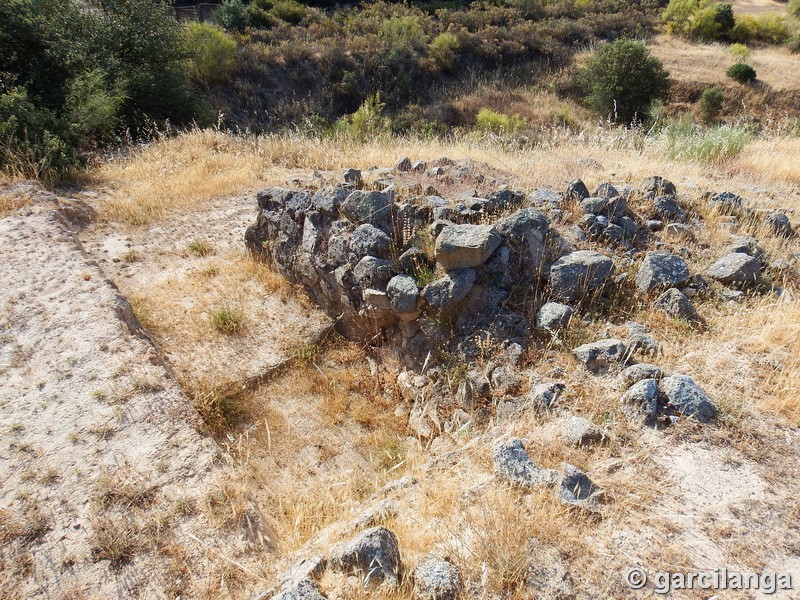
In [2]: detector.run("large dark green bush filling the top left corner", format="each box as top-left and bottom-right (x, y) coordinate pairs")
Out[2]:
(0, 0), (203, 176)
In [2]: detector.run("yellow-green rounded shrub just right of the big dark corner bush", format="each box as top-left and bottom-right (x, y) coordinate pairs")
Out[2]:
(183, 22), (236, 85)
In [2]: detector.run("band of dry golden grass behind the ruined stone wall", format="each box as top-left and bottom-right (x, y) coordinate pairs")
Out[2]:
(93, 124), (800, 230)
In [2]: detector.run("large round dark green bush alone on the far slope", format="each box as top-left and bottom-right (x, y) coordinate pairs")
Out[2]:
(580, 40), (669, 123)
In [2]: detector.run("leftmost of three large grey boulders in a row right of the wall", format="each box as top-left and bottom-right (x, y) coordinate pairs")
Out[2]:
(550, 250), (614, 302)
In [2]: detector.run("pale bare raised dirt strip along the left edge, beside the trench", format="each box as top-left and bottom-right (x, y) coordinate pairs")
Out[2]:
(0, 201), (234, 598)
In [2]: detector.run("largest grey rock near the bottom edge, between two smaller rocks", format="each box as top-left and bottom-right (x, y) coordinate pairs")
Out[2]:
(328, 526), (400, 585)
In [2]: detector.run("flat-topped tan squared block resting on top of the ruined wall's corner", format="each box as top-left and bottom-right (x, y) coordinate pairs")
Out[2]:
(436, 225), (503, 271)
